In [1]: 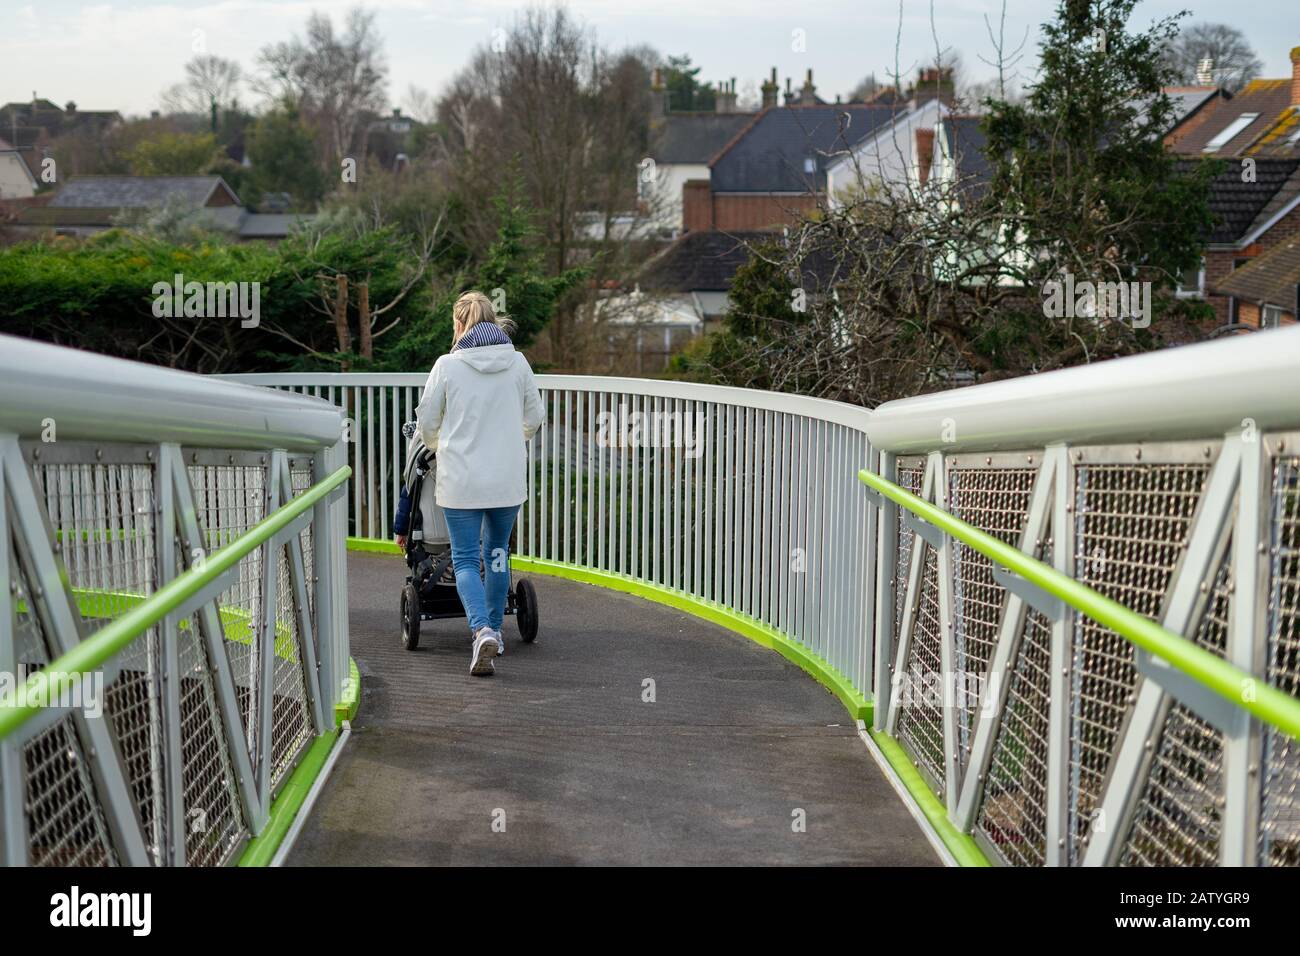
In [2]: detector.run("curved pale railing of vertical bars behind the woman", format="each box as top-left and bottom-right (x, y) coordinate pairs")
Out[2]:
(229, 373), (875, 688)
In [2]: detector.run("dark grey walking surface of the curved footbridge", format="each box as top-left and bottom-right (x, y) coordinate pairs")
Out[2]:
(289, 554), (939, 865)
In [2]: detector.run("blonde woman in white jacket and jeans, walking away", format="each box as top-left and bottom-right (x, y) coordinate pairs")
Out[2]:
(416, 291), (545, 676)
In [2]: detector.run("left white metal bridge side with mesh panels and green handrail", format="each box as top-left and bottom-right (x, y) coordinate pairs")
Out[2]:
(0, 337), (350, 865)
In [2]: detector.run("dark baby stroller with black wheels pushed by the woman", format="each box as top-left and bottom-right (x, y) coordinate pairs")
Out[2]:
(402, 423), (537, 650)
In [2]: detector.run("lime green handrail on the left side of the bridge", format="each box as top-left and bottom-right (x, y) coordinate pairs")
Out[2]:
(0, 464), (352, 739)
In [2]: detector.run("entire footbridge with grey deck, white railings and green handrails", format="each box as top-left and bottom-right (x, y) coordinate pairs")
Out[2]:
(0, 329), (1300, 866)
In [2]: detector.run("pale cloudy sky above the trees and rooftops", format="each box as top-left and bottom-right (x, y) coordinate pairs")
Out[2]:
(10, 0), (1300, 114)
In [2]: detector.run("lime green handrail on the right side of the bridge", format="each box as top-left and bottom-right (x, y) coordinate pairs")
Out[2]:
(858, 468), (1300, 740)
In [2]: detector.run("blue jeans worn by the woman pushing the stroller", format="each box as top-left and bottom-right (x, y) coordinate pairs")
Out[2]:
(442, 505), (519, 631)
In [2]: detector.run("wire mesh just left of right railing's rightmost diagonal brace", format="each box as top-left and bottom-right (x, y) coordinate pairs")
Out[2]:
(1069, 460), (1209, 864)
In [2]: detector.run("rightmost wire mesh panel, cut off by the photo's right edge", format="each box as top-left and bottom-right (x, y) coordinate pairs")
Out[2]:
(1260, 457), (1300, 866)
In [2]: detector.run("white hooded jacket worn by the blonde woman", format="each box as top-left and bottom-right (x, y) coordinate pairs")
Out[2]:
(416, 345), (545, 509)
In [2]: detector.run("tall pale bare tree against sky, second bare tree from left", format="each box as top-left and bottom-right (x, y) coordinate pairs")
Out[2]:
(257, 7), (387, 163)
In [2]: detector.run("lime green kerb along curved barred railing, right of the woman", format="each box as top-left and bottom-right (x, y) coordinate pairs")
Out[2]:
(510, 554), (871, 723)
